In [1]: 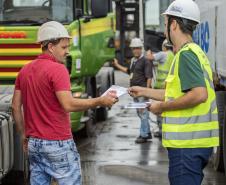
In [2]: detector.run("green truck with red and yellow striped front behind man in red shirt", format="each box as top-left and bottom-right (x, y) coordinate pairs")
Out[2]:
(0, 0), (114, 184)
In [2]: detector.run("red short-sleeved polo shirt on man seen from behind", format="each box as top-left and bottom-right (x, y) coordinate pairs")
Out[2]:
(15, 54), (72, 140)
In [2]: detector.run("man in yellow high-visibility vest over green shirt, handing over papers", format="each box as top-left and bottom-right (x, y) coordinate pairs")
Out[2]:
(129, 0), (219, 185)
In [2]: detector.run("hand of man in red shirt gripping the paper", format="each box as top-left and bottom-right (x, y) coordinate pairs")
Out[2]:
(100, 91), (118, 107)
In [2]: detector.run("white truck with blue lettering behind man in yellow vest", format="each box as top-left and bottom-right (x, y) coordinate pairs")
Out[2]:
(193, 0), (226, 174)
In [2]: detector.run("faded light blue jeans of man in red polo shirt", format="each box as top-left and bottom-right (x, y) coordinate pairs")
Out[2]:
(28, 138), (82, 185)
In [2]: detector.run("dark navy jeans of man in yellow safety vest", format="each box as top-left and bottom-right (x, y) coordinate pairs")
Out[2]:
(168, 148), (213, 185)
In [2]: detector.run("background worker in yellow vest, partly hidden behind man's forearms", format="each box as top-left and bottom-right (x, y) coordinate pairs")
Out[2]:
(146, 39), (174, 137)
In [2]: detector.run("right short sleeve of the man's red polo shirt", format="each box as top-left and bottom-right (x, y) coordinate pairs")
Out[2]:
(51, 64), (71, 92)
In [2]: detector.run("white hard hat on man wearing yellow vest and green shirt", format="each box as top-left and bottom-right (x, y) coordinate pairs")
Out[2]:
(163, 0), (200, 23)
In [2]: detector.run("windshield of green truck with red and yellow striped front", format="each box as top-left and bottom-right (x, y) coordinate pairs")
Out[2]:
(0, 0), (73, 25)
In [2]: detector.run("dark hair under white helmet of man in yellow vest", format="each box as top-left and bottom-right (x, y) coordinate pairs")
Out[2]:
(168, 16), (197, 36)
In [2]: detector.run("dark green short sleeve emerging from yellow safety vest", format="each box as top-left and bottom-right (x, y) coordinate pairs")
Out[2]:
(179, 51), (206, 92)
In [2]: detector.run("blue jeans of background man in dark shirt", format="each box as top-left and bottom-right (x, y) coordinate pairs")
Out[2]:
(134, 97), (151, 137)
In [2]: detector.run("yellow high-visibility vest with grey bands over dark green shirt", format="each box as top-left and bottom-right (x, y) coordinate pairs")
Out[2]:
(162, 43), (219, 148)
